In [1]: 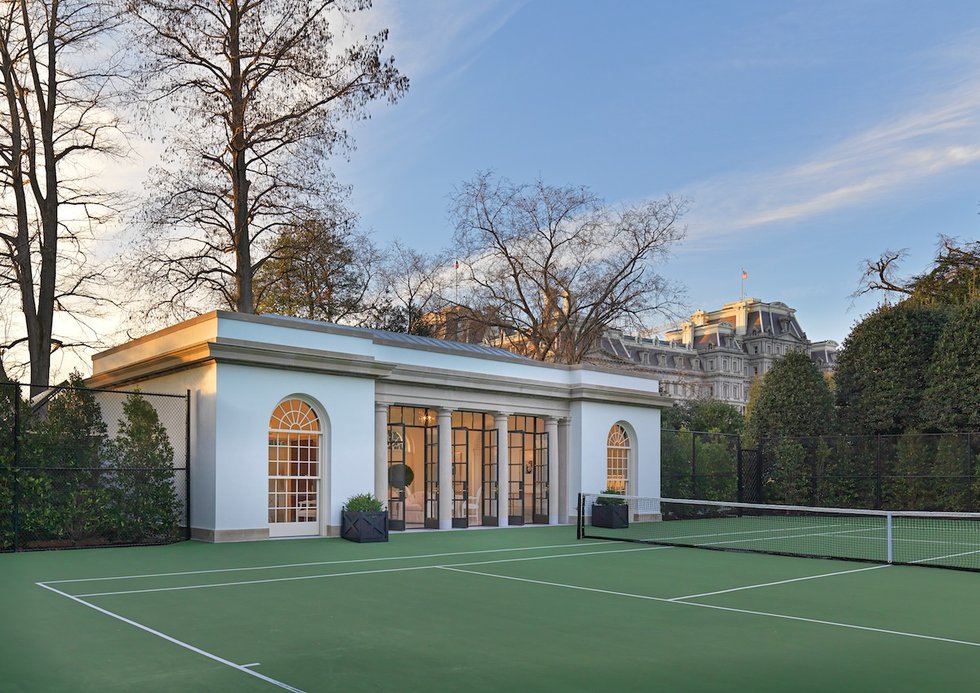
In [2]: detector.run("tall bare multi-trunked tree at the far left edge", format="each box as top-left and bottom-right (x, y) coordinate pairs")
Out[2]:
(0, 0), (121, 392)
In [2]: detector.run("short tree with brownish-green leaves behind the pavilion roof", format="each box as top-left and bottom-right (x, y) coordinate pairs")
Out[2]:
(255, 207), (379, 322)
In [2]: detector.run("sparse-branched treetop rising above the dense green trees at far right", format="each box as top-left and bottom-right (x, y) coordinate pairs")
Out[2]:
(855, 235), (980, 304)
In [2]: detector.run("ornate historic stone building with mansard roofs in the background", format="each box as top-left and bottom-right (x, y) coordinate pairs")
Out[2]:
(590, 298), (837, 410)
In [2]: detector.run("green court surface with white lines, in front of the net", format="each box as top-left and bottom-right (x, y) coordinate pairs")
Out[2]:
(0, 523), (980, 691)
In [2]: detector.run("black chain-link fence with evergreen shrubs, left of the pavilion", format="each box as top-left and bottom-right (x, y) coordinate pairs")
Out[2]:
(0, 383), (190, 551)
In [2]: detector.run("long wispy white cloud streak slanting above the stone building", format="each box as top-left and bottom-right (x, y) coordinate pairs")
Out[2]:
(684, 73), (980, 237)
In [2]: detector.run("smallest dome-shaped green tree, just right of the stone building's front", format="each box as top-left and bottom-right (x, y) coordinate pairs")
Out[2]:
(747, 351), (834, 441)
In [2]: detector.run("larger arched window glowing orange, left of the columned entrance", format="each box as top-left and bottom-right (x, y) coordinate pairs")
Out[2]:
(269, 399), (322, 536)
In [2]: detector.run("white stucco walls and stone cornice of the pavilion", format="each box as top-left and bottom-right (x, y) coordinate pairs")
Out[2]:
(93, 312), (665, 540)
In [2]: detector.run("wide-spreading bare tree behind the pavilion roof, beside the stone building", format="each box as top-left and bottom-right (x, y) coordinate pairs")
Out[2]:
(451, 173), (685, 363)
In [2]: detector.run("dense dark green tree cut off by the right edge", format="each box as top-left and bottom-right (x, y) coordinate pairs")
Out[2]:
(922, 301), (980, 432)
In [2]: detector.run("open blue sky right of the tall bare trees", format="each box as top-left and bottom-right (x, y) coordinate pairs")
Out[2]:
(334, 0), (980, 341)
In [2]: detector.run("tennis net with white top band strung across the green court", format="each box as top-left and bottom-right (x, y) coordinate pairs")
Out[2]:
(578, 494), (980, 571)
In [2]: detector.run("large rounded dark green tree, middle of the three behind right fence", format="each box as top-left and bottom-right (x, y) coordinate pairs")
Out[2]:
(835, 304), (949, 434)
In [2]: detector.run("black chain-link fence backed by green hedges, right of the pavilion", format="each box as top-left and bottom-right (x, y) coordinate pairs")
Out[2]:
(661, 430), (980, 512)
